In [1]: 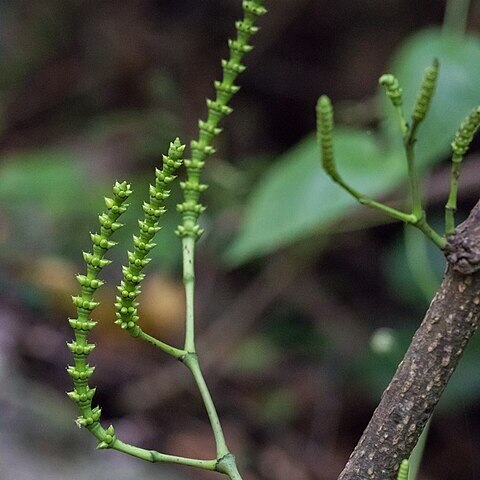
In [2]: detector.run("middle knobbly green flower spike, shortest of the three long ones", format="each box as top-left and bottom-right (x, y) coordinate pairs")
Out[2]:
(115, 138), (185, 336)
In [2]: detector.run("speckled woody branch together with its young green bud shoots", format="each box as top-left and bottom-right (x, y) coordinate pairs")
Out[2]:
(317, 59), (480, 480)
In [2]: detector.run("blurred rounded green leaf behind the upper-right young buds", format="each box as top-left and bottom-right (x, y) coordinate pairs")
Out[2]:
(382, 28), (480, 166)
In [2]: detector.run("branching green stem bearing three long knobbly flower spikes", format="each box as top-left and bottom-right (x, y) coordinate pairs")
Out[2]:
(67, 0), (266, 480)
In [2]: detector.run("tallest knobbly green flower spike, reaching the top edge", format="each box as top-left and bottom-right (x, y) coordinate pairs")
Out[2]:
(176, 0), (267, 239)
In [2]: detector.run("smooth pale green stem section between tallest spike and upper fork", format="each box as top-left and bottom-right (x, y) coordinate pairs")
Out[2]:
(182, 237), (195, 353)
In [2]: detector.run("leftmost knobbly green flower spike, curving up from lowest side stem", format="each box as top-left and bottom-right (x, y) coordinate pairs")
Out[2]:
(67, 182), (132, 430)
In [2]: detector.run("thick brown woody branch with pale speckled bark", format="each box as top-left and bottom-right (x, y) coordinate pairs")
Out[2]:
(338, 202), (480, 480)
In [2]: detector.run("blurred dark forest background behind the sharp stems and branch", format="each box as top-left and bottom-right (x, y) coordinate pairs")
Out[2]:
(0, 0), (480, 480)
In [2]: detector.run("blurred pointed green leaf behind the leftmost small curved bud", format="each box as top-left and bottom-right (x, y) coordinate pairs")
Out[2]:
(227, 128), (405, 264)
